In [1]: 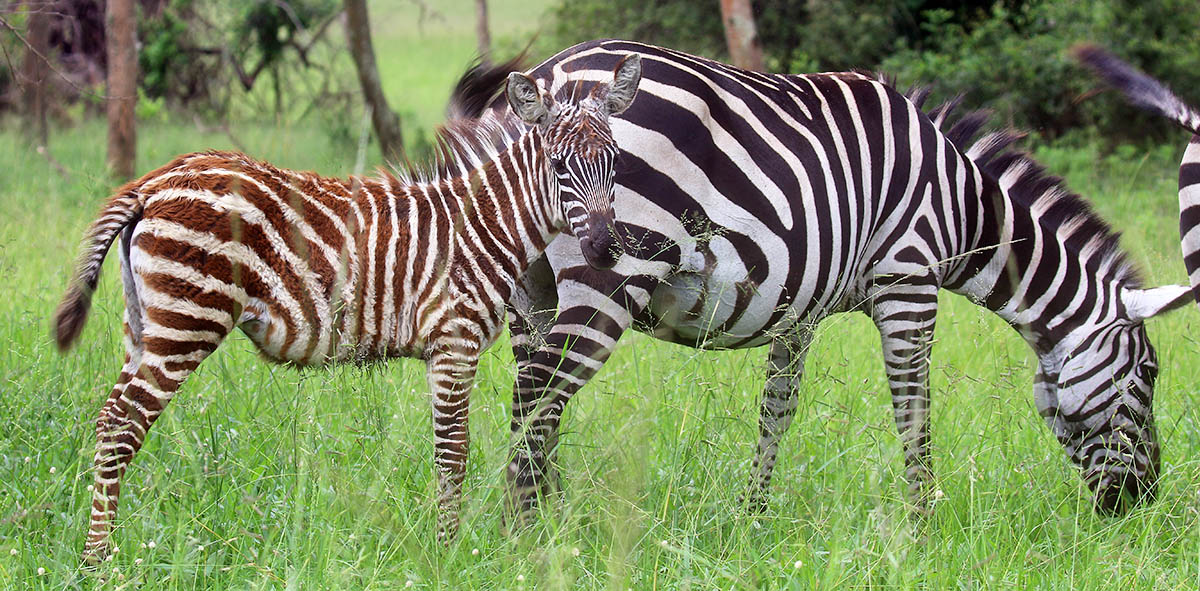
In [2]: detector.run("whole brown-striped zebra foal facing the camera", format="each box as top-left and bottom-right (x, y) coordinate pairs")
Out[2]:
(55, 55), (640, 562)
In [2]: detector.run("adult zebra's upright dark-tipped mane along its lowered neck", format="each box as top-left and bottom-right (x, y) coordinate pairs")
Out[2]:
(902, 78), (1142, 287)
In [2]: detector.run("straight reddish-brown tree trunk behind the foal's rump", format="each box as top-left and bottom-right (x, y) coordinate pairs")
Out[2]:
(104, 0), (138, 180)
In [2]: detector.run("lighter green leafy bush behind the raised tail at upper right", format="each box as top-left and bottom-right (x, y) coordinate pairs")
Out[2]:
(881, 0), (1200, 142)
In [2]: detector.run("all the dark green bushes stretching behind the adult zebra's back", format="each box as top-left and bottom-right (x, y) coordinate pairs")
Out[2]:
(551, 0), (1200, 141)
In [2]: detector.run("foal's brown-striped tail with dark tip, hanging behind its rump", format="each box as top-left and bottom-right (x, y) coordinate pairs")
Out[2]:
(54, 179), (144, 351)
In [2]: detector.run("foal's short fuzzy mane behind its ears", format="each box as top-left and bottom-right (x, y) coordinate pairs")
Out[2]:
(391, 112), (524, 184)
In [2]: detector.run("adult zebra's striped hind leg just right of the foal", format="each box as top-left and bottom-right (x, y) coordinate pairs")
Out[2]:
(505, 279), (649, 519)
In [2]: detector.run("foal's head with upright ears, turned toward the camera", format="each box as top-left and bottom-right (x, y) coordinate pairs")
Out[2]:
(508, 54), (642, 269)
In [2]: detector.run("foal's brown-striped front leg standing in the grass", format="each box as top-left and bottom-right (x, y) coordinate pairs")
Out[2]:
(426, 341), (480, 543)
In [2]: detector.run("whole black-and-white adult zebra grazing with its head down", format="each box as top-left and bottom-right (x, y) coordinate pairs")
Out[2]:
(456, 40), (1187, 513)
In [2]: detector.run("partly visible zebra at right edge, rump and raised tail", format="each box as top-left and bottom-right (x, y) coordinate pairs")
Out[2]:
(1073, 44), (1200, 304)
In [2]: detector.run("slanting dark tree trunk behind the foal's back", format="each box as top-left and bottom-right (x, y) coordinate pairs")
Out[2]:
(346, 0), (404, 162)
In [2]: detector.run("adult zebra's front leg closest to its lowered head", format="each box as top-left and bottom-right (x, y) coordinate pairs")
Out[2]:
(871, 277), (938, 513)
